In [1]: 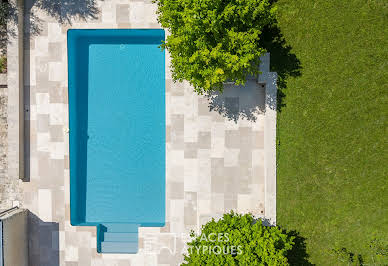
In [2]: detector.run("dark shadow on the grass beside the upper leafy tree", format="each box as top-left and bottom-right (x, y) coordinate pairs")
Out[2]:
(260, 22), (302, 112)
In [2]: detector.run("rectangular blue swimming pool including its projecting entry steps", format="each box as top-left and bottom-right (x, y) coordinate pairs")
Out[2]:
(67, 29), (165, 253)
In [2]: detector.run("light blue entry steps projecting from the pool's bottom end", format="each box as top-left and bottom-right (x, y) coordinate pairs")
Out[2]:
(97, 223), (140, 254)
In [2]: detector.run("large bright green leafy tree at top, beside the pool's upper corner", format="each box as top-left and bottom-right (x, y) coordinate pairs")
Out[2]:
(154, 0), (275, 93)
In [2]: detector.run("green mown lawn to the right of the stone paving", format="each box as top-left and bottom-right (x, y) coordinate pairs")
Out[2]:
(271, 0), (388, 265)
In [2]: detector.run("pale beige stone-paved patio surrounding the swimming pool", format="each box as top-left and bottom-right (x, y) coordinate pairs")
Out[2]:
(4, 0), (276, 266)
